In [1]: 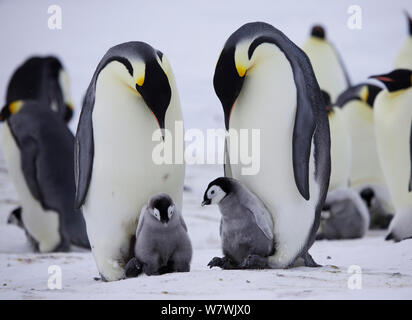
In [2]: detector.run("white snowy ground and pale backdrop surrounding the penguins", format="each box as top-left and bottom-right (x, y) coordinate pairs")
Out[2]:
(0, 0), (412, 299)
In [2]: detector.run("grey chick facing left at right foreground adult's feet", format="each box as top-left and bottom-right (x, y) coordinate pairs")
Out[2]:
(202, 177), (275, 269)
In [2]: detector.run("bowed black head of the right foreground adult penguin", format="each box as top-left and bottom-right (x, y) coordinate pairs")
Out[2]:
(213, 22), (275, 129)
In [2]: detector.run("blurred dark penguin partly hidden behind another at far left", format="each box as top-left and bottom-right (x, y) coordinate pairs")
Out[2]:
(6, 56), (73, 122)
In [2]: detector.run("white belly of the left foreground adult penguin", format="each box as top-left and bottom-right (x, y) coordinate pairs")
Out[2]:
(83, 72), (184, 280)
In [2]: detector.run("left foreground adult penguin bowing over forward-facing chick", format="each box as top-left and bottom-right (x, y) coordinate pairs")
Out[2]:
(75, 42), (184, 281)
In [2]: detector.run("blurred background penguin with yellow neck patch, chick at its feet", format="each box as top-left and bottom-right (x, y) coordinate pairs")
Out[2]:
(336, 83), (394, 229)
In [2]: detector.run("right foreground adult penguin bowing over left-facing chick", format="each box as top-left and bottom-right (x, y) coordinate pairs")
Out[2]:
(213, 22), (330, 268)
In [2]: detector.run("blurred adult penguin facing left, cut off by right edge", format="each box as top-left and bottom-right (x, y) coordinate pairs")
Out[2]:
(371, 69), (412, 241)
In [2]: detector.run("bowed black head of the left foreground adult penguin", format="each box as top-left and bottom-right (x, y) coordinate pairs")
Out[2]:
(98, 41), (172, 138)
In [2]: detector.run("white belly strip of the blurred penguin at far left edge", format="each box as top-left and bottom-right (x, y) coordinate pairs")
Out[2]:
(2, 122), (60, 252)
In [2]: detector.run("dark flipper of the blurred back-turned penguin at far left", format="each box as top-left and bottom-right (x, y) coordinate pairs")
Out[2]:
(21, 137), (46, 208)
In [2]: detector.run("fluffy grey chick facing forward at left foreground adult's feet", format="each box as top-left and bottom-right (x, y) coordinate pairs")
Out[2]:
(125, 193), (192, 277)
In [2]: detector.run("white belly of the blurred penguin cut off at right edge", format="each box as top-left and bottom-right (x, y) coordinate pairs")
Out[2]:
(374, 89), (412, 212)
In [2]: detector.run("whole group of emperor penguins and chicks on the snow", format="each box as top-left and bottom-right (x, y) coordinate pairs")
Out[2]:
(0, 12), (412, 281)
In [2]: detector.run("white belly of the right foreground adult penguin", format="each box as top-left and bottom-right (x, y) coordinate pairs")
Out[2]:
(228, 44), (319, 267)
